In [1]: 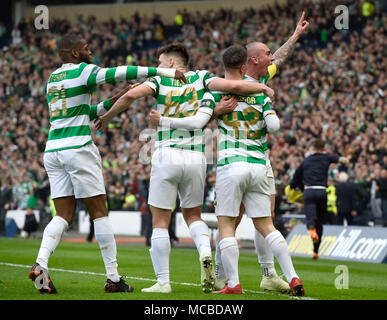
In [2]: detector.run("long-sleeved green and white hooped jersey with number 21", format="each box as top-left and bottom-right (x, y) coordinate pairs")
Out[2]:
(45, 63), (161, 152)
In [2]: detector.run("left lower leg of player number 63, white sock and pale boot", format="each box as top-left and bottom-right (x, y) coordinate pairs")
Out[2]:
(141, 205), (172, 293)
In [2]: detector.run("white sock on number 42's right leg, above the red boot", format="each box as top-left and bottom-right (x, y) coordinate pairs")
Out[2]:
(265, 230), (298, 282)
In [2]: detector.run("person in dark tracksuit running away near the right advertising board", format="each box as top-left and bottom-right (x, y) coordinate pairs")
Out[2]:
(290, 139), (348, 259)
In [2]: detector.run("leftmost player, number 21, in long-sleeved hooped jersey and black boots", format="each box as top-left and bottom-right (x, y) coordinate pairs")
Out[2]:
(29, 34), (185, 293)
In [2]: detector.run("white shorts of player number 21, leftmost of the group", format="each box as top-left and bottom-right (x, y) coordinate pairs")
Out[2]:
(44, 143), (106, 199)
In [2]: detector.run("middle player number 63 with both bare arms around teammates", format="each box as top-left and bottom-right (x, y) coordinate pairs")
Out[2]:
(97, 43), (273, 293)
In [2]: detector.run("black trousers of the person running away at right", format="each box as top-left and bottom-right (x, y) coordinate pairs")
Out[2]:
(303, 189), (327, 253)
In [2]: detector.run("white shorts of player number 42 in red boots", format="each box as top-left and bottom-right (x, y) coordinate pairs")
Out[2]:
(215, 162), (271, 218)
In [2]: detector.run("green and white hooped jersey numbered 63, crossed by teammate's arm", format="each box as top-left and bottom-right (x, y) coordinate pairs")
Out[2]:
(144, 70), (215, 152)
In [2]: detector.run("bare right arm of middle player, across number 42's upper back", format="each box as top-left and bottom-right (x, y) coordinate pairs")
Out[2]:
(208, 78), (274, 100)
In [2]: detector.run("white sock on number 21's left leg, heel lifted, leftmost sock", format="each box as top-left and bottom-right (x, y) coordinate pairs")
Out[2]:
(36, 216), (69, 269)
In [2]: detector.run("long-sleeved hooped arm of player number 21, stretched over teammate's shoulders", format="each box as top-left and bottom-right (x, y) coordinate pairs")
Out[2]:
(86, 65), (187, 88)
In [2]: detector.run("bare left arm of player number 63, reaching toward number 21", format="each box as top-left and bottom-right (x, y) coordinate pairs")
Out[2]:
(94, 84), (154, 130)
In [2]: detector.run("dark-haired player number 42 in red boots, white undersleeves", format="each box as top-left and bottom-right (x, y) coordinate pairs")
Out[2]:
(151, 46), (304, 295)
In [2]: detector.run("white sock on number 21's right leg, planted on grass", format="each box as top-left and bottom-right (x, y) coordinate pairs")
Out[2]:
(94, 217), (120, 282)
